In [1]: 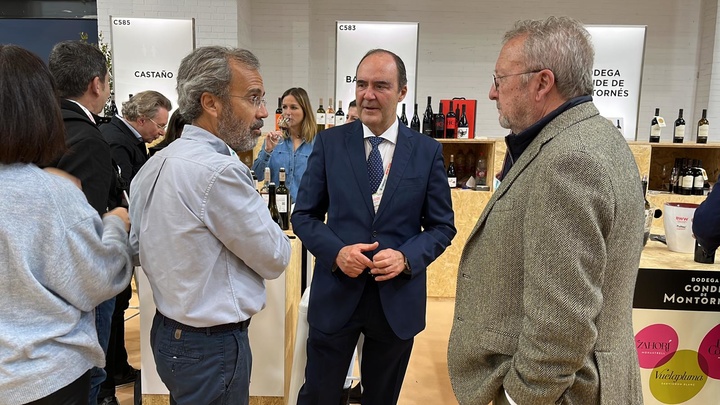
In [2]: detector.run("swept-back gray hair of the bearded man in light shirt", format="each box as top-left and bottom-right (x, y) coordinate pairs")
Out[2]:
(177, 46), (260, 122)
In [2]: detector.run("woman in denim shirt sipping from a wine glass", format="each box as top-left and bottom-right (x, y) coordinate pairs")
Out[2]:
(252, 87), (316, 201)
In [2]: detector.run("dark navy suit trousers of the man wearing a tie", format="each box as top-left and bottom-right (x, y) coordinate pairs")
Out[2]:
(298, 277), (414, 405)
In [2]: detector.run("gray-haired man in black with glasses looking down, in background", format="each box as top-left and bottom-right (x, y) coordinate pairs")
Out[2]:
(98, 91), (172, 405)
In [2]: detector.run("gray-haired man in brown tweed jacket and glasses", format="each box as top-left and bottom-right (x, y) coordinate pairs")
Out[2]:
(448, 17), (643, 405)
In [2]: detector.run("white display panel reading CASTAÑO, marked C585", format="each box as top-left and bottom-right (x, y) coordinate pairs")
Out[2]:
(110, 16), (195, 110)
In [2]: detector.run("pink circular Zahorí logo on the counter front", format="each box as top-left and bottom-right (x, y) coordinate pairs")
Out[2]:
(635, 323), (678, 369)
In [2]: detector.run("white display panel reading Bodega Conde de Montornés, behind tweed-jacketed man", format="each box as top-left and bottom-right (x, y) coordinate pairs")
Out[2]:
(585, 25), (649, 141)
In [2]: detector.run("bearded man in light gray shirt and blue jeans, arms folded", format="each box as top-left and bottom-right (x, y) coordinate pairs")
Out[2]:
(130, 46), (290, 405)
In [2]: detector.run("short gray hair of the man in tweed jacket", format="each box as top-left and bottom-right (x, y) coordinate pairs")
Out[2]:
(503, 17), (595, 100)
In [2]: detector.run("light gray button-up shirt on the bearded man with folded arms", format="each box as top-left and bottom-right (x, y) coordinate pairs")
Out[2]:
(130, 125), (290, 327)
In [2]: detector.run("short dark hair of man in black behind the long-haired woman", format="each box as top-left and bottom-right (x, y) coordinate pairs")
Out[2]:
(48, 41), (107, 98)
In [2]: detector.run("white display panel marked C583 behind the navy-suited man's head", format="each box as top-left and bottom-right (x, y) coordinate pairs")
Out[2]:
(335, 21), (419, 119)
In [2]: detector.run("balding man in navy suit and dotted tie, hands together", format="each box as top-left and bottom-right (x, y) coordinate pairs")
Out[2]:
(292, 49), (456, 405)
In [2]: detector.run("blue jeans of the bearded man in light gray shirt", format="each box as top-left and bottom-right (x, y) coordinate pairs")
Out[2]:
(150, 312), (252, 405)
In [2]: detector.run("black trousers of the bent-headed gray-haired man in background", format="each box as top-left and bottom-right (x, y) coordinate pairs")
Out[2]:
(98, 284), (132, 398)
